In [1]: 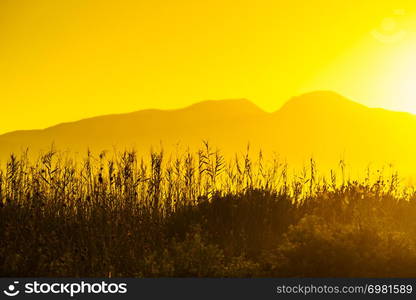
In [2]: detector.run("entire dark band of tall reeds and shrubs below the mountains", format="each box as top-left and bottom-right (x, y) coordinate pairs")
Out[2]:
(0, 142), (416, 277)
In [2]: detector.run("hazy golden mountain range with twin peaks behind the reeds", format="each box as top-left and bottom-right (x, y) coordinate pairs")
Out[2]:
(0, 91), (416, 173)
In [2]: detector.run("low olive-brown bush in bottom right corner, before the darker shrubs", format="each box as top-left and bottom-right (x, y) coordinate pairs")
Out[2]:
(266, 215), (416, 277)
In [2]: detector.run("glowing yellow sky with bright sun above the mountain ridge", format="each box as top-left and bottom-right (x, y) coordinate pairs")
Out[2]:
(0, 0), (416, 132)
